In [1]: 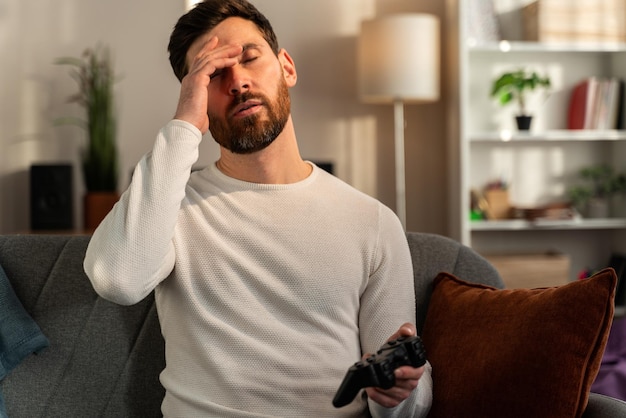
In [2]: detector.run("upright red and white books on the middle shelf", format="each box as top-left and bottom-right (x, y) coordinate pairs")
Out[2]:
(567, 76), (626, 130)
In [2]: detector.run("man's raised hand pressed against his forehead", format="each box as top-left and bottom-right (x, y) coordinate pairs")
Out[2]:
(174, 36), (243, 134)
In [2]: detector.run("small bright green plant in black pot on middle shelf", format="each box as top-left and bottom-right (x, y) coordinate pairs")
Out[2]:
(491, 69), (550, 130)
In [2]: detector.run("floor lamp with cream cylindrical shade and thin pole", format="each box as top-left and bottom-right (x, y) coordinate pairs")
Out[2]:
(357, 13), (440, 228)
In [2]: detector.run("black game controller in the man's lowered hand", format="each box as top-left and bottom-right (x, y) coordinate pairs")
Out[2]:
(333, 335), (426, 408)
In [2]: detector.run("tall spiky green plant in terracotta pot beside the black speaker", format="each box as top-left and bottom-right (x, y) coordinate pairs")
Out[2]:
(56, 46), (119, 229)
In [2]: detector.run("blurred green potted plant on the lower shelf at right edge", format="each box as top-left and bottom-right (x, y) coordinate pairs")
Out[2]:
(568, 164), (626, 218)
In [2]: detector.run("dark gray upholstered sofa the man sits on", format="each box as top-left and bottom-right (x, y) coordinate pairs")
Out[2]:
(0, 233), (626, 418)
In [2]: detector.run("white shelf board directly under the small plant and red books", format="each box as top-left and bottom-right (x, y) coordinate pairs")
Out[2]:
(469, 129), (626, 142)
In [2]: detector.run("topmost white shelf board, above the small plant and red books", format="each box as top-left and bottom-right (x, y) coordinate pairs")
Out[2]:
(468, 40), (626, 53)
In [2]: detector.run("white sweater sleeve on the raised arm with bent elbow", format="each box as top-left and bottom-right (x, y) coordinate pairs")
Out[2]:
(84, 120), (202, 305)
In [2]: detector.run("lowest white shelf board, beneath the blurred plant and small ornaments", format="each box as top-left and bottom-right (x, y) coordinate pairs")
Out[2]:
(470, 218), (626, 231)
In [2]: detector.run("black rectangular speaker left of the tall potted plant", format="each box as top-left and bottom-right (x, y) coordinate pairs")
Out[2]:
(30, 164), (74, 230)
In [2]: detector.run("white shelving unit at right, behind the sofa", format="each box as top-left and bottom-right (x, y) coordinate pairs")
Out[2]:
(446, 0), (626, 278)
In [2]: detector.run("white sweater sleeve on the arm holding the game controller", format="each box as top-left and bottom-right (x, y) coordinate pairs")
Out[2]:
(359, 205), (432, 418)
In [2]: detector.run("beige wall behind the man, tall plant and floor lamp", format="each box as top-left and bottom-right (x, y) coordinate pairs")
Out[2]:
(0, 0), (447, 233)
